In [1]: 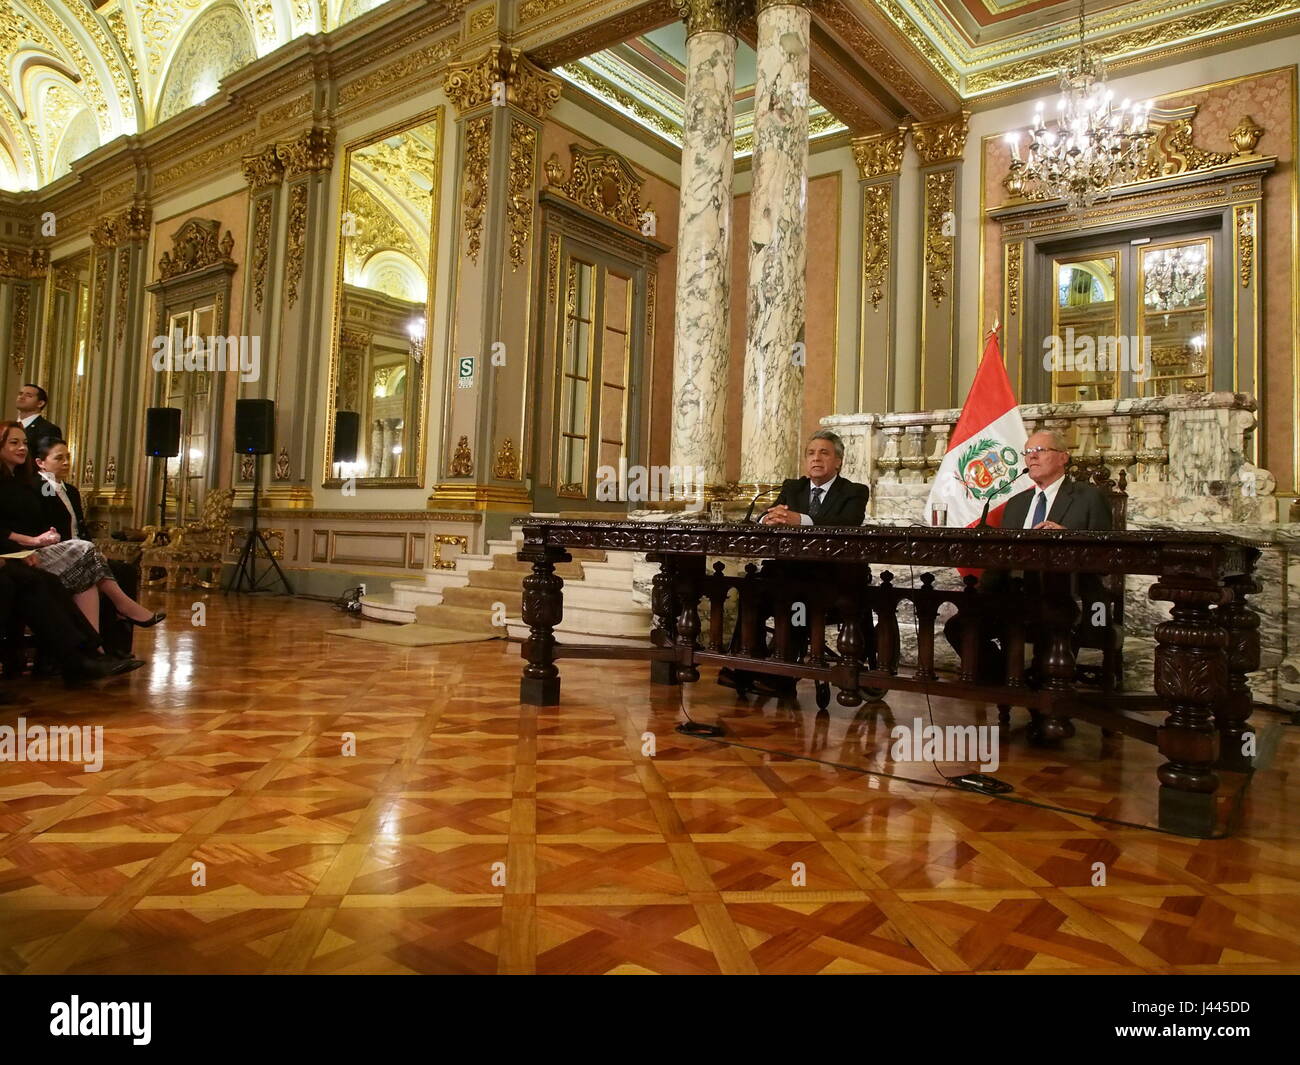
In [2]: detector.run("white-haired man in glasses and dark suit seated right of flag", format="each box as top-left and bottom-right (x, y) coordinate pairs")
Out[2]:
(944, 430), (1113, 683)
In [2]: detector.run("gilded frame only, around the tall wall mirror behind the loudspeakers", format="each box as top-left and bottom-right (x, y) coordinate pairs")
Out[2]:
(321, 105), (446, 489)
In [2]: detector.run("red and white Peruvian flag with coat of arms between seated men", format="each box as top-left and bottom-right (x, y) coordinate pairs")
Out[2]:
(927, 326), (1027, 527)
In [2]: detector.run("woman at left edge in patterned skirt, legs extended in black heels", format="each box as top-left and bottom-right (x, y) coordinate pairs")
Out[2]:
(0, 421), (166, 632)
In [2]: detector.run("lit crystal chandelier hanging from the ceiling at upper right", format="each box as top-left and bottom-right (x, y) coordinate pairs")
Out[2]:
(1004, 0), (1154, 211)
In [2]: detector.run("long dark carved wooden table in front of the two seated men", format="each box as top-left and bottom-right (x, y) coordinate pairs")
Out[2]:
(519, 520), (1260, 836)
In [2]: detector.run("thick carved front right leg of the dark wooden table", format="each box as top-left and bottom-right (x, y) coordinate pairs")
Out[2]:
(1148, 576), (1230, 836)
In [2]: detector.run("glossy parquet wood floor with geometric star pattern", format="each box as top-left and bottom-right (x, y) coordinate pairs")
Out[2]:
(0, 594), (1300, 973)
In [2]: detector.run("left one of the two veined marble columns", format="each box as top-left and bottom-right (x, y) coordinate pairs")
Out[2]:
(670, 0), (736, 495)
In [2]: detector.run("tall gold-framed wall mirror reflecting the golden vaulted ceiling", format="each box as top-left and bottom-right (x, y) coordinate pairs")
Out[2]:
(324, 108), (442, 488)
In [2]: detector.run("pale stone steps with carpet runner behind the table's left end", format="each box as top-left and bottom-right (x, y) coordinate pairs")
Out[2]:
(361, 533), (651, 646)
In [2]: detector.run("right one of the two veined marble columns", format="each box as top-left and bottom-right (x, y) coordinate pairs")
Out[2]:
(740, 0), (810, 490)
